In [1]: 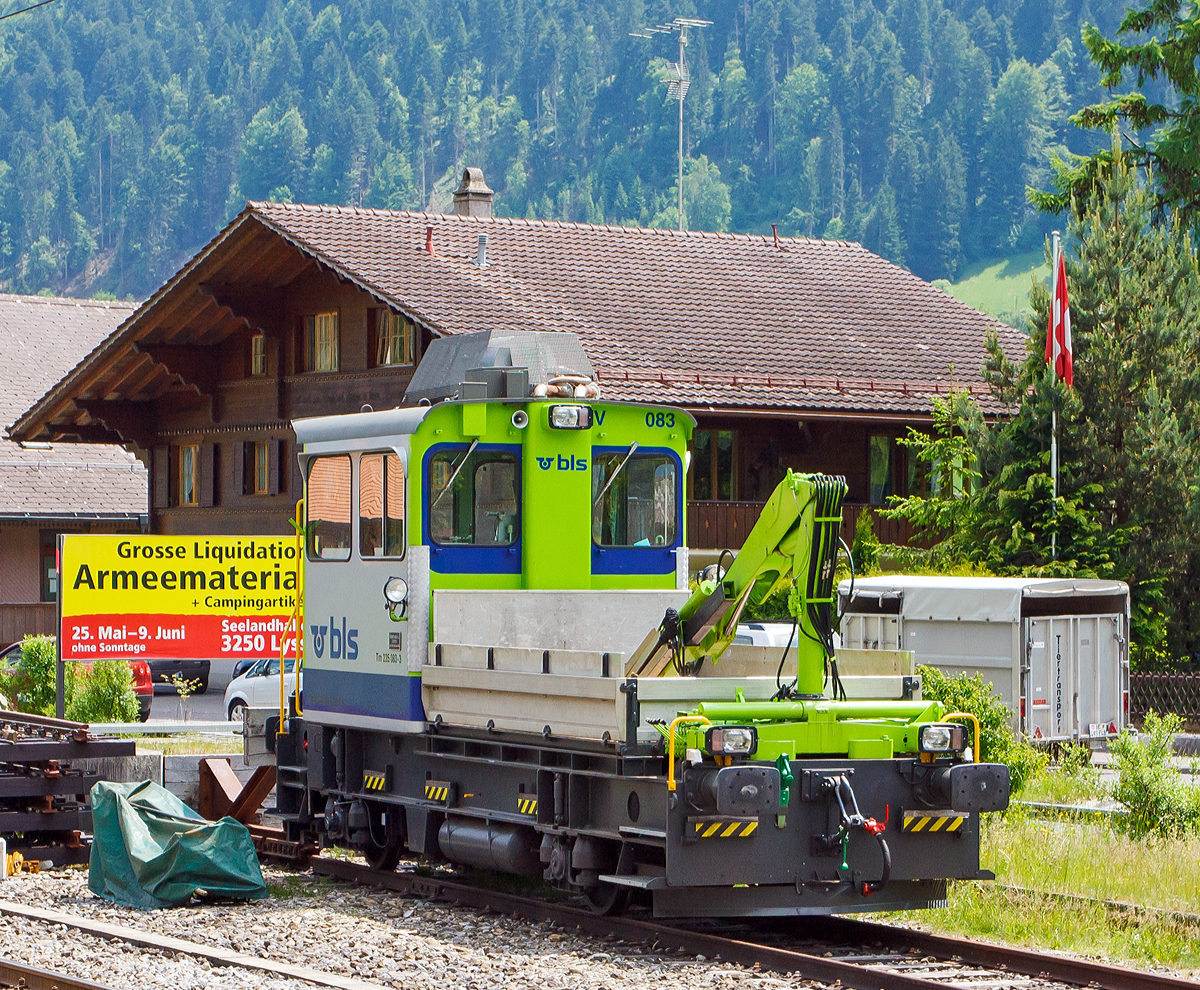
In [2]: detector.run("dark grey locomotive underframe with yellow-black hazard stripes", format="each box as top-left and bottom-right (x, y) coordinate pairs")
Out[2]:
(277, 718), (992, 917)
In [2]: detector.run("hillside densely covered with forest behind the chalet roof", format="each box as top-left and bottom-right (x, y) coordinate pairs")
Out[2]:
(0, 0), (1137, 296)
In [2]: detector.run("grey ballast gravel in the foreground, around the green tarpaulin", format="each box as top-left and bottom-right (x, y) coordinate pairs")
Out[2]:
(0, 868), (821, 990)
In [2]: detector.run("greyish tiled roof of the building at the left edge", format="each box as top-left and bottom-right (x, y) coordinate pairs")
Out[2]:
(0, 294), (146, 517)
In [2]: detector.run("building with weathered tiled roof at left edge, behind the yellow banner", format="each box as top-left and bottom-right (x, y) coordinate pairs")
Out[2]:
(0, 295), (149, 647)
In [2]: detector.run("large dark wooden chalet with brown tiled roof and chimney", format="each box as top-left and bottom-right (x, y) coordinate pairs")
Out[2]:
(12, 169), (1024, 548)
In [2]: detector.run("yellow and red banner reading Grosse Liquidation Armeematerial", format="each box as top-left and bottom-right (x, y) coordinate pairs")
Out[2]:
(59, 535), (296, 660)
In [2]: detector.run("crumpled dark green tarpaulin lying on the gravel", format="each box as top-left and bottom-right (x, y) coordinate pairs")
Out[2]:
(88, 780), (266, 910)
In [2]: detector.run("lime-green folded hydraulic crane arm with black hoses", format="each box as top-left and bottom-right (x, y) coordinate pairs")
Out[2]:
(640, 470), (846, 695)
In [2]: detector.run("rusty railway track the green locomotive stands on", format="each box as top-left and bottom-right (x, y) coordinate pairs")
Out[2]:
(312, 857), (1196, 990)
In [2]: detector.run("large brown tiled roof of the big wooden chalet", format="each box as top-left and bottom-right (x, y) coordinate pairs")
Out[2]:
(247, 203), (1025, 414)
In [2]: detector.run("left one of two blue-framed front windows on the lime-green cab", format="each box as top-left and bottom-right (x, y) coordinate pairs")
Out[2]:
(428, 448), (521, 547)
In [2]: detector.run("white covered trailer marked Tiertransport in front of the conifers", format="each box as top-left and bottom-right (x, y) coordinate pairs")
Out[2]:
(838, 575), (1129, 743)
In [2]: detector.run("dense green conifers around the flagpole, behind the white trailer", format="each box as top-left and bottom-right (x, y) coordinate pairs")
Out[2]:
(892, 157), (1200, 670)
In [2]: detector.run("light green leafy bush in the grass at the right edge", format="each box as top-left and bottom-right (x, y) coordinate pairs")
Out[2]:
(1109, 712), (1200, 839)
